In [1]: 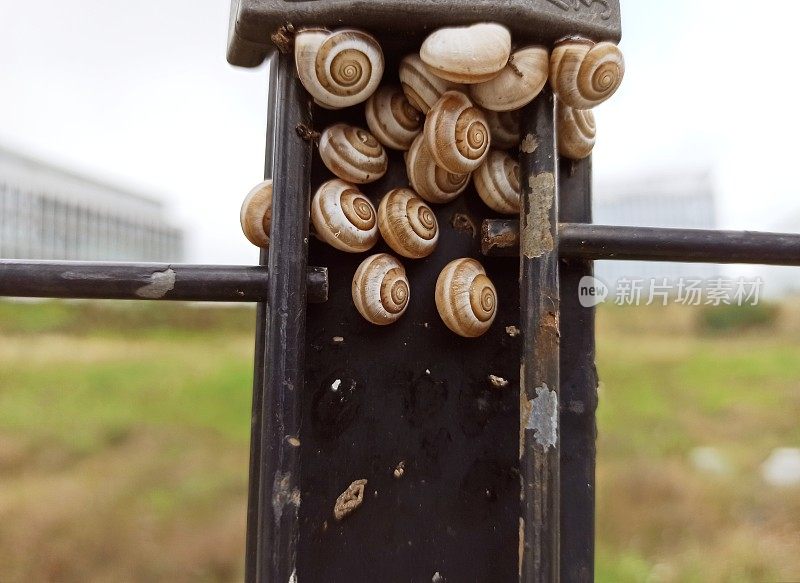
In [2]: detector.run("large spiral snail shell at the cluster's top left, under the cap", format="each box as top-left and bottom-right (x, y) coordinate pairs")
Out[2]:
(294, 29), (384, 109)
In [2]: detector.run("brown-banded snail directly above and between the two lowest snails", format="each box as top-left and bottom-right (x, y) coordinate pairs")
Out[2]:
(378, 188), (439, 259)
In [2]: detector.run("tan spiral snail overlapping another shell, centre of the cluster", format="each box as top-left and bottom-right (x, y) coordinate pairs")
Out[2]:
(423, 91), (491, 174)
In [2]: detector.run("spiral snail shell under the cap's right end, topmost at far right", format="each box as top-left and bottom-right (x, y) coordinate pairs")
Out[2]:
(550, 38), (625, 109)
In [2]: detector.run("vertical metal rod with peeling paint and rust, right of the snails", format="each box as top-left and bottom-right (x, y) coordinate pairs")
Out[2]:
(519, 87), (560, 583)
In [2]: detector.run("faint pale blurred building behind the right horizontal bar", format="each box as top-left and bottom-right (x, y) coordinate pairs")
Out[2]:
(593, 172), (720, 289)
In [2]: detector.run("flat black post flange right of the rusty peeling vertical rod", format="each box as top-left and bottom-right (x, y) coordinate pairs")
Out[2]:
(559, 158), (597, 583)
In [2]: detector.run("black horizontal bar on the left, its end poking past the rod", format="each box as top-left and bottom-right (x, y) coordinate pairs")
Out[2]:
(0, 259), (328, 303)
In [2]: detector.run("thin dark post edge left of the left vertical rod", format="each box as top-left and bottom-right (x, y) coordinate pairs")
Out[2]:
(244, 55), (278, 582)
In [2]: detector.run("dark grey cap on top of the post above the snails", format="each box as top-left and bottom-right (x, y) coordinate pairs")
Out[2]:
(228, 0), (622, 67)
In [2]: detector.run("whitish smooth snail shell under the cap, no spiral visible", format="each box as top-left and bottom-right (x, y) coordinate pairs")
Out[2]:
(419, 23), (511, 83)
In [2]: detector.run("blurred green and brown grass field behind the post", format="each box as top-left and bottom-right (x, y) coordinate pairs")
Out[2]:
(0, 302), (800, 582)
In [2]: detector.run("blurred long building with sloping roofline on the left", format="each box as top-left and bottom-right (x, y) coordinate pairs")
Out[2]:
(0, 147), (183, 262)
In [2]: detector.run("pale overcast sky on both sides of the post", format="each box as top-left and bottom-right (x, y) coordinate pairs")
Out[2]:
(0, 0), (800, 263)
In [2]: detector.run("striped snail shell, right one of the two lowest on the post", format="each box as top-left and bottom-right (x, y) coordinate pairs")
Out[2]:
(436, 259), (497, 338)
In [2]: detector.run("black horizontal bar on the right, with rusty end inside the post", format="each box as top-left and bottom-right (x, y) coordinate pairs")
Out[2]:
(481, 219), (800, 265)
